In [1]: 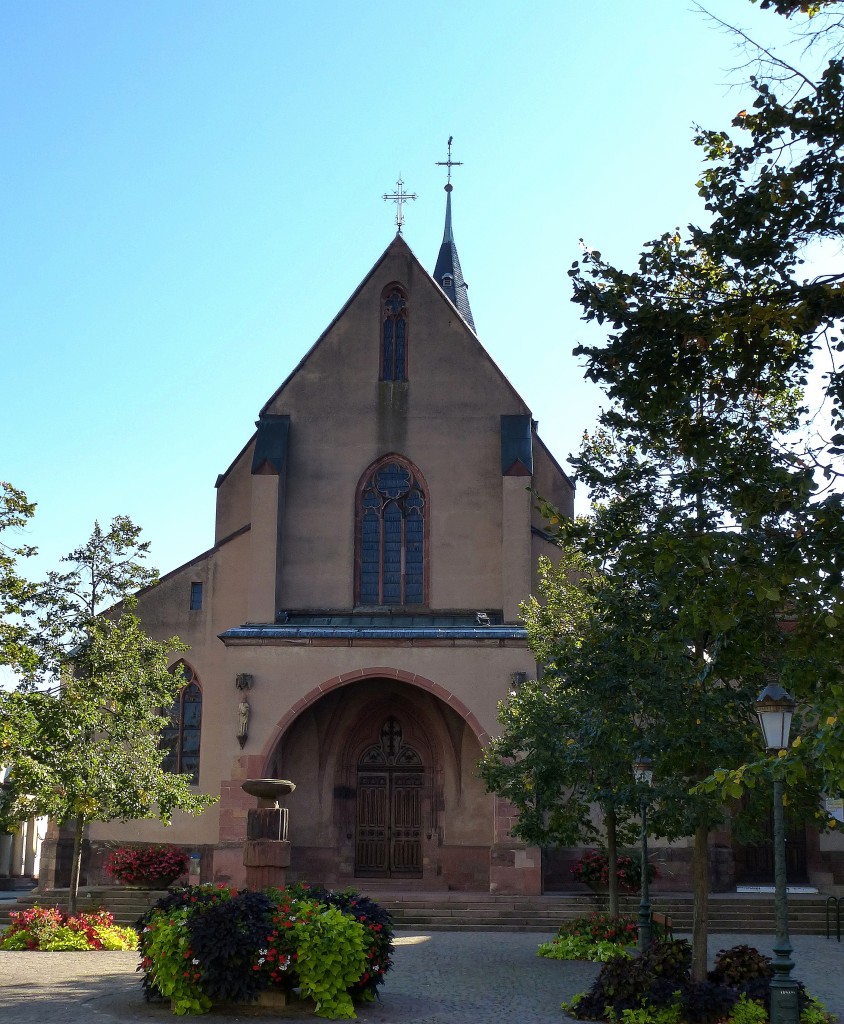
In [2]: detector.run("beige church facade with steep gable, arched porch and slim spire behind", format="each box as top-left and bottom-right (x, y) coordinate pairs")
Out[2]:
(51, 185), (574, 892)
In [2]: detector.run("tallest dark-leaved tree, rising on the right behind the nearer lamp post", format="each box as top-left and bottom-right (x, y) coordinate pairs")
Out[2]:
(536, 0), (844, 977)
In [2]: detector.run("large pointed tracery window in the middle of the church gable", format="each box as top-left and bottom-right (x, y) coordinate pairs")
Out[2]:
(355, 455), (428, 607)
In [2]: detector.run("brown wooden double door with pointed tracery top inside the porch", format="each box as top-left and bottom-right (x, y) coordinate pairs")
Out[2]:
(354, 716), (425, 879)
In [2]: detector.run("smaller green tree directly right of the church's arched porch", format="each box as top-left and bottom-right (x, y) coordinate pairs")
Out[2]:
(479, 548), (635, 914)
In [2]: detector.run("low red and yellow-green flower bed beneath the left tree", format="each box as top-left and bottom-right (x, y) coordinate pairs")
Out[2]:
(0, 906), (137, 952)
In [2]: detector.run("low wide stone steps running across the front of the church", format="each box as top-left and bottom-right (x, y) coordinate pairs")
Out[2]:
(0, 885), (835, 935)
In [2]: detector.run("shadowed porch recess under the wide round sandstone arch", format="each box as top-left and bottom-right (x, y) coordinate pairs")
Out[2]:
(265, 675), (494, 891)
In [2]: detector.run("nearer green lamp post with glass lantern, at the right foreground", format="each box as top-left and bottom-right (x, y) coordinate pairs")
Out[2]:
(755, 683), (800, 1024)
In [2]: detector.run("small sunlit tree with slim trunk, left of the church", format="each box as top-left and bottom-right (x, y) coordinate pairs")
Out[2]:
(0, 517), (213, 911)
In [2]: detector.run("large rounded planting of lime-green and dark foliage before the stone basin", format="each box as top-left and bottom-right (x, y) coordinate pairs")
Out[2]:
(138, 886), (392, 1018)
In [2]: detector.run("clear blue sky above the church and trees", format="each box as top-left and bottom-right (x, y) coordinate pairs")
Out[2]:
(0, 0), (803, 571)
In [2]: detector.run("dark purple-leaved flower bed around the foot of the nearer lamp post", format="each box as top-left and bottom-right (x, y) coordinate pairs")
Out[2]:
(562, 940), (833, 1024)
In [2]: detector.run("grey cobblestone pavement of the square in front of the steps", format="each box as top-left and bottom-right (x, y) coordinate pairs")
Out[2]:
(0, 932), (844, 1024)
